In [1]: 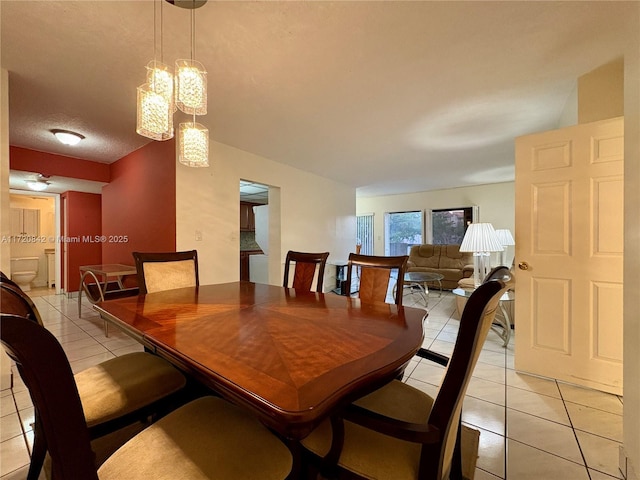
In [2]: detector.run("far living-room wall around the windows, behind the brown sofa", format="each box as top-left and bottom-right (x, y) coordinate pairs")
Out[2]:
(356, 182), (518, 255)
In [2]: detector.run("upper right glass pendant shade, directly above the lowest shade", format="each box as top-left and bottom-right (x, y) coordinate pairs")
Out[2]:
(175, 60), (207, 115)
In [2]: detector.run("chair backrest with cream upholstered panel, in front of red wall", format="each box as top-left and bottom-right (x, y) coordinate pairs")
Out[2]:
(133, 250), (200, 294)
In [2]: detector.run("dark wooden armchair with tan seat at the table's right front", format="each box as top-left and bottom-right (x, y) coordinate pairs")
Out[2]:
(302, 279), (509, 480)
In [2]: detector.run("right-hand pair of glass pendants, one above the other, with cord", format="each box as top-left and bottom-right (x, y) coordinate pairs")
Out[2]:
(175, 0), (209, 167)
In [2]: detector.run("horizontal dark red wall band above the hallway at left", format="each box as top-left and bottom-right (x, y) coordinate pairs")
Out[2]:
(9, 146), (110, 182)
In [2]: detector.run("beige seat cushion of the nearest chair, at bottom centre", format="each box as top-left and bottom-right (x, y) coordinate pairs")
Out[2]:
(98, 397), (292, 480)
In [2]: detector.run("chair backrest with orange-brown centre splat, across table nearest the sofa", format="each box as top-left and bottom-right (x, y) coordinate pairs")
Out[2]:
(347, 253), (409, 305)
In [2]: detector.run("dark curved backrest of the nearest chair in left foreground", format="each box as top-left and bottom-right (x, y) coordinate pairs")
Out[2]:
(0, 313), (98, 480)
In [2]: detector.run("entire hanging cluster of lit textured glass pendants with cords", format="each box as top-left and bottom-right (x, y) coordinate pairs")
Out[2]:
(136, 0), (209, 167)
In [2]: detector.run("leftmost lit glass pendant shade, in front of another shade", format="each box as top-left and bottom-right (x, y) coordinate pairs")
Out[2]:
(136, 83), (173, 140)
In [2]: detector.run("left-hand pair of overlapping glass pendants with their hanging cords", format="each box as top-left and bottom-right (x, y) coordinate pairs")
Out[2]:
(136, 0), (175, 141)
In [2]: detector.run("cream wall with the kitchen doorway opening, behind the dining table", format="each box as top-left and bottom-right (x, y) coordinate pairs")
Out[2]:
(176, 141), (356, 287)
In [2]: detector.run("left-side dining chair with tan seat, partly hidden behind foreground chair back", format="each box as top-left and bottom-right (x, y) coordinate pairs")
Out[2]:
(0, 282), (186, 480)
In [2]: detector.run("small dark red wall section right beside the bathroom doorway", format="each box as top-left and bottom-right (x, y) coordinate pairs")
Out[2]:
(60, 191), (103, 292)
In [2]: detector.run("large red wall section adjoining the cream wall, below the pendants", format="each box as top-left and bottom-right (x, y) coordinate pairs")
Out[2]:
(102, 140), (176, 265)
